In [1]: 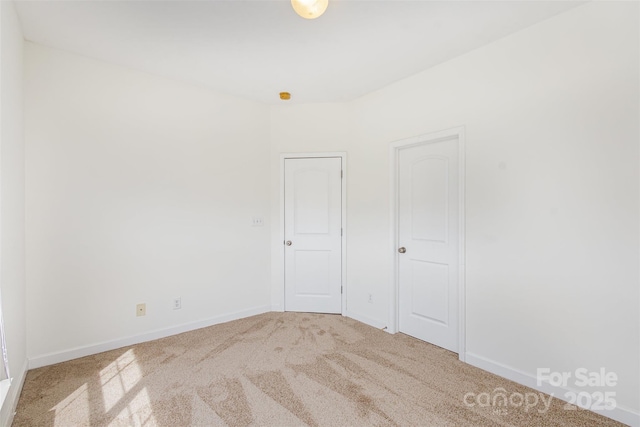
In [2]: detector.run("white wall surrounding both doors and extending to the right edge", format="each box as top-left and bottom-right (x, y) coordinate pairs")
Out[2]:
(271, 3), (640, 422)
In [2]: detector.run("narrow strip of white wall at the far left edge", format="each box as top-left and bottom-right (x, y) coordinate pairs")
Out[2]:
(0, 1), (27, 425)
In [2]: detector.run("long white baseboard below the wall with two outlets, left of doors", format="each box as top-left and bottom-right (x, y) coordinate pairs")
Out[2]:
(29, 305), (271, 369)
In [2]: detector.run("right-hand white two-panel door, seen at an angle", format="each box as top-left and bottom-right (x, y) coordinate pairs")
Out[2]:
(398, 137), (459, 352)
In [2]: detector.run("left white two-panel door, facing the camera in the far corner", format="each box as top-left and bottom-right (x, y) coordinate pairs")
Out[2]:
(283, 157), (342, 313)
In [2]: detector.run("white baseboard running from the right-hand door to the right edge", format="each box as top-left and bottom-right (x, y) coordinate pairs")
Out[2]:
(466, 352), (640, 427)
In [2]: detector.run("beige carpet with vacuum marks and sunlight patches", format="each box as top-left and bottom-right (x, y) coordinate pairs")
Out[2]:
(13, 313), (621, 427)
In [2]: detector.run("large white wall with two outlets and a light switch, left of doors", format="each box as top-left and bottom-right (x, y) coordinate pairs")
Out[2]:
(25, 43), (270, 367)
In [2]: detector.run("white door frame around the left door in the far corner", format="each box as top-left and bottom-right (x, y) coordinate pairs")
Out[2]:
(277, 151), (347, 316)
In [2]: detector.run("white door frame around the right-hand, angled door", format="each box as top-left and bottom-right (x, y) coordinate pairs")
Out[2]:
(389, 127), (466, 362)
